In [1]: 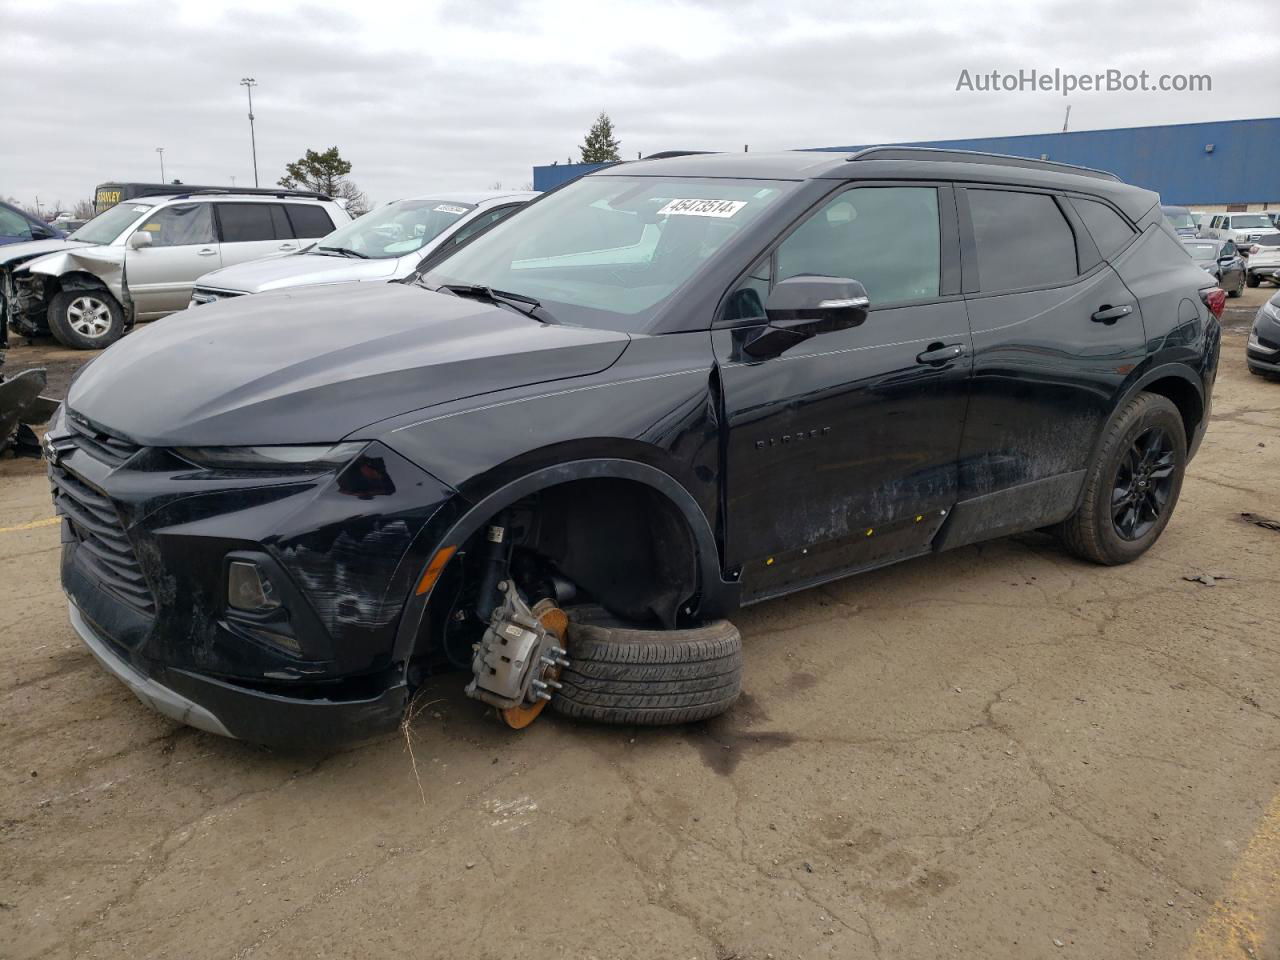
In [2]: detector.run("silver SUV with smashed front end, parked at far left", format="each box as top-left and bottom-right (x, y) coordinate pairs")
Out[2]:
(0, 191), (351, 349)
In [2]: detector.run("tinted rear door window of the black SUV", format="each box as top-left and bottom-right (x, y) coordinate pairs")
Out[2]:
(968, 189), (1078, 293)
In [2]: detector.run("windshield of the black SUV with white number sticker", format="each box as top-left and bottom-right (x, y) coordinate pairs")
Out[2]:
(422, 175), (796, 332)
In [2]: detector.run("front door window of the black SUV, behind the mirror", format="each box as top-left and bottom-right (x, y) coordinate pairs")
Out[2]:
(773, 187), (942, 306)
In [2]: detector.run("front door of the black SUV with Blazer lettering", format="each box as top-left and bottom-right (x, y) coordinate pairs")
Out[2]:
(712, 184), (970, 602)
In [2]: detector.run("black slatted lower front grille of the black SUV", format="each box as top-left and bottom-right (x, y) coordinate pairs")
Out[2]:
(49, 465), (155, 614)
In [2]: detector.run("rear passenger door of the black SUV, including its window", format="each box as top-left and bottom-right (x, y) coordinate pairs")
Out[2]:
(941, 186), (1146, 547)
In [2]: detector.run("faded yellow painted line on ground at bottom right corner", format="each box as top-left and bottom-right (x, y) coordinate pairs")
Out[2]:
(1187, 795), (1280, 960)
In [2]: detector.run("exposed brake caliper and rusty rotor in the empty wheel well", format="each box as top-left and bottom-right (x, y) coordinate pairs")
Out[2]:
(466, 580), (568, 730)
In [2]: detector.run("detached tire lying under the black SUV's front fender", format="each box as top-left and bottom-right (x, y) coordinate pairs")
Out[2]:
(550, 620), (742, 726)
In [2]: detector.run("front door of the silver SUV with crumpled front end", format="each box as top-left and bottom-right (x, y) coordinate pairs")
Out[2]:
(124, 204), (221, 320)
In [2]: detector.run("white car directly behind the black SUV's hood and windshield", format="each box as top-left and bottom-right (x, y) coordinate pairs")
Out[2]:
(191, 191), (538, 306)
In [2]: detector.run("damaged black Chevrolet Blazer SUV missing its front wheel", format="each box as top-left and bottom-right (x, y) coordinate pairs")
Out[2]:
(45, 147), (1224, 744)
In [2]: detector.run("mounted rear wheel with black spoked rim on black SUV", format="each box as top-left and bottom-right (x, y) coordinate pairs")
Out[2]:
(1057, 393), (1187, 566)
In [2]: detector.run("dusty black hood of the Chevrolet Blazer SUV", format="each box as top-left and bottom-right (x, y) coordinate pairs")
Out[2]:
(67, 283), (630, 447)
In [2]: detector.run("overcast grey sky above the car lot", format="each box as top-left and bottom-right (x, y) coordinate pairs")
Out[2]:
(0, 0), (1280, 212)
